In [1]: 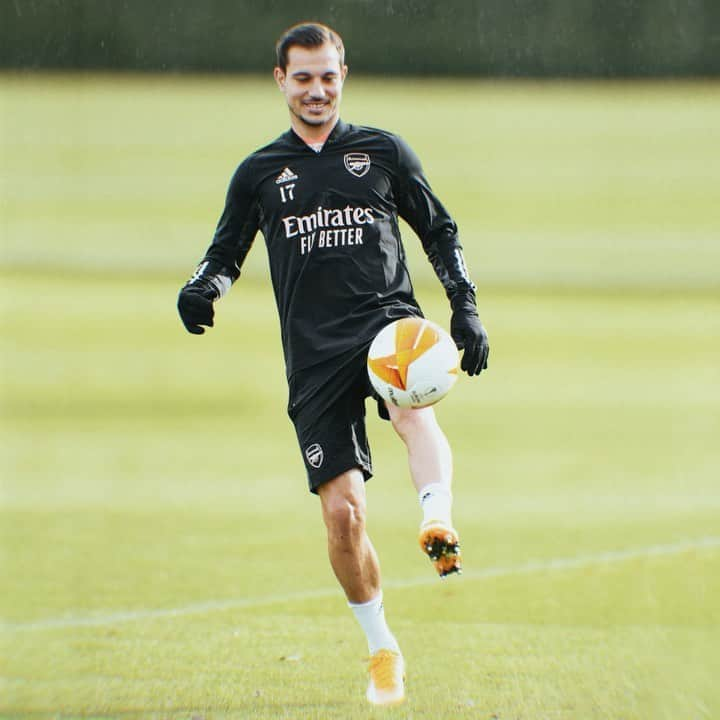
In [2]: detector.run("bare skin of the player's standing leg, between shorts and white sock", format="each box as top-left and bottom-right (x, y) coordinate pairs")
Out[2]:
(318, 468), (380, 603)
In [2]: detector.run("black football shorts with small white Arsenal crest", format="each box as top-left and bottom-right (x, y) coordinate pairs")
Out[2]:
(288, 347), (389, 493)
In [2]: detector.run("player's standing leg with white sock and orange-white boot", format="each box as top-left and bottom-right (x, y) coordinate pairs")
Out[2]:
(318, 468), (405, 705)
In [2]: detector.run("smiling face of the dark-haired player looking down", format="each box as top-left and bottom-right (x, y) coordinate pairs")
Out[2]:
(275, 43), (347, 130)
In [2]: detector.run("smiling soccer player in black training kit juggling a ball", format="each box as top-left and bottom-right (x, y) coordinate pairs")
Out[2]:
(178, 23), (489, 705)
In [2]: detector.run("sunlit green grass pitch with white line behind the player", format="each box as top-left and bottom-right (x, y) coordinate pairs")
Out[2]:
(0, 75), (720, 720)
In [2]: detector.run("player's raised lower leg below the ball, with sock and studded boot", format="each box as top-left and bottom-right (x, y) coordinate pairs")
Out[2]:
(387, 403), (462, 577)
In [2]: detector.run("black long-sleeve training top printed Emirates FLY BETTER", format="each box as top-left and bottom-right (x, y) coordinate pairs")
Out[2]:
(190, 121), (474, 377)
